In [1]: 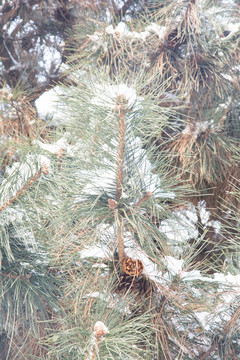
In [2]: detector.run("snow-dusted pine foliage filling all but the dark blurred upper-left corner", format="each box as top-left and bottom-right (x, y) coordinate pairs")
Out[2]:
(0, 0), (240, 360)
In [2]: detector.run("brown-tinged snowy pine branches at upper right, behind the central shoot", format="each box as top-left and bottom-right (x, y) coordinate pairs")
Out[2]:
(73, 1), (239, 273)
